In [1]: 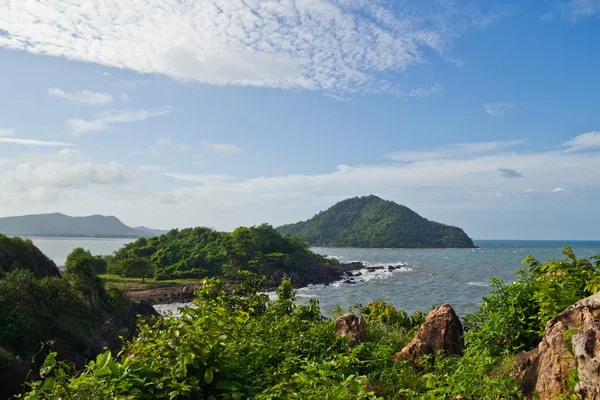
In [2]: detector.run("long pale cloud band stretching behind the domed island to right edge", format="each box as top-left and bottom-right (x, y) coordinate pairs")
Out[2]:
(155, 146), (600, 222)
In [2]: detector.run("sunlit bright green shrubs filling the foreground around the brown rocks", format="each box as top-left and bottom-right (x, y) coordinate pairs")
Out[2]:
(21, 247), (600, 400)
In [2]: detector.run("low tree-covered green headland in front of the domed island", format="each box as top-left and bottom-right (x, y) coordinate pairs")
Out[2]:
(109, 224), (332, 279)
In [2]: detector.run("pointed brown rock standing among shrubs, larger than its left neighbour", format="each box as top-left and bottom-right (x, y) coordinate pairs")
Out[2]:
(392, 304), (464, 366)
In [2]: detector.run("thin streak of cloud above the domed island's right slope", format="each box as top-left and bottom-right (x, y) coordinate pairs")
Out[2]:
(386, 139), (526, 162)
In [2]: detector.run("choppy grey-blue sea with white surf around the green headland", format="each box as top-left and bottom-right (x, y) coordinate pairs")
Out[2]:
(30, 237), (600, 316)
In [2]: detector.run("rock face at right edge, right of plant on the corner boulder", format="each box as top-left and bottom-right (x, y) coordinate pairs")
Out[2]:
(571, 322), (600, 400)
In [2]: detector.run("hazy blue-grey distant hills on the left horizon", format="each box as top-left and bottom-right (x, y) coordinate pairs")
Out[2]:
(0, 213), (162, 238)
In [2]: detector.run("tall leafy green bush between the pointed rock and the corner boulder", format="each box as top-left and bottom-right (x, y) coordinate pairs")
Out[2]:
(465, 246), (600, 355)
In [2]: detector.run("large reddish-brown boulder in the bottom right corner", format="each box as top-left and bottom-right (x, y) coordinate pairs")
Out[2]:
(521, 293), (600, 400)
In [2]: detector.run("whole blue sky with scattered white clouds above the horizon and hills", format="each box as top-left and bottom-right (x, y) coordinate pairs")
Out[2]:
(0, 0), (600, 240)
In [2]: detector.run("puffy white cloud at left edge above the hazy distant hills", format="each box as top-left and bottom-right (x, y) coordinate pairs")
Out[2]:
(0, 149), (133, 202)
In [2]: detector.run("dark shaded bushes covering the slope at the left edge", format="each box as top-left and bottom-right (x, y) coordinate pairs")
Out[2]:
(0, 241), (128, 360)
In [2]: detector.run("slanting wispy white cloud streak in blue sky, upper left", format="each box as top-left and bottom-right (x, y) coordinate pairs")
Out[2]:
(67, 107), (172, 135)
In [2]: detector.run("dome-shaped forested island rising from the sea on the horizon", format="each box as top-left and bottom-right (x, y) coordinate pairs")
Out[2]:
(277, 195), (475, 248)
